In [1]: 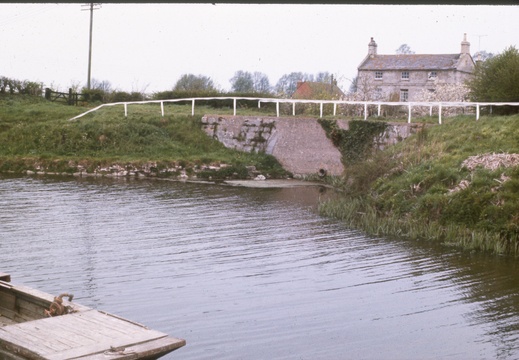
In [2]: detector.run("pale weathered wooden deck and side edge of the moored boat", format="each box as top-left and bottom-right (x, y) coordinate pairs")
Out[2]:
(0, 274), (186, 360)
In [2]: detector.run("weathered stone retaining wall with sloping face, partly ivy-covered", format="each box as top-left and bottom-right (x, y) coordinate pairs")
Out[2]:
(202, 115), (416, 176)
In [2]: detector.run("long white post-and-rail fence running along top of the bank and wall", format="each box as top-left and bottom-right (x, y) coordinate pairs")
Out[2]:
(70, 97), (519, 124)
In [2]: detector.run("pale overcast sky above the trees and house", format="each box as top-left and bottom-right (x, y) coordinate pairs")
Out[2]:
(0, 3), (519, 93)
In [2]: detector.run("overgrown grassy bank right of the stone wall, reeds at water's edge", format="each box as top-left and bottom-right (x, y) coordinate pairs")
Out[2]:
(320, 115), (519, 256)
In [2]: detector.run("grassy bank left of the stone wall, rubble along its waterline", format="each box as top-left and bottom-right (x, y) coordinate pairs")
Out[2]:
(0, 95), (287, 179)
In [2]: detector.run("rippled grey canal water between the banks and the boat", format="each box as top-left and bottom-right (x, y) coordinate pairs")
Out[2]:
(0, 177), (519, 360)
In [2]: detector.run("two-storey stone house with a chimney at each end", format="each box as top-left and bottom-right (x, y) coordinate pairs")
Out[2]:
(357, 34), (475, 101)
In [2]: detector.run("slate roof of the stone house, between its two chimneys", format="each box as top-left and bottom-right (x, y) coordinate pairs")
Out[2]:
(359, 54), (462, 70)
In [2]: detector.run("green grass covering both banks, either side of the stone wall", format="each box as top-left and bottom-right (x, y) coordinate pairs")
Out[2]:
(5, 96), (519, 256)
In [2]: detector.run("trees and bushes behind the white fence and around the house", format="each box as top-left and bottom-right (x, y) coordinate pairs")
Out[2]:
(0, 44), (519, 109)
